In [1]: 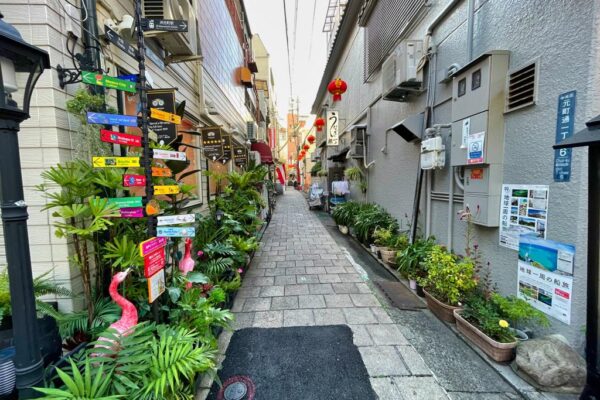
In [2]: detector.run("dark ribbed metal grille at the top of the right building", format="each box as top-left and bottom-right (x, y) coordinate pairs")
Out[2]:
(365, 0), (427, 79)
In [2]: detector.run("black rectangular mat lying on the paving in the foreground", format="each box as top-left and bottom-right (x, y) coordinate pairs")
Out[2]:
(207, 325), (377, 400)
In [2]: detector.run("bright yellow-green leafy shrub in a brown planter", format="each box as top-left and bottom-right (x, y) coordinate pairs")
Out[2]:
(418, 245), (477, 323)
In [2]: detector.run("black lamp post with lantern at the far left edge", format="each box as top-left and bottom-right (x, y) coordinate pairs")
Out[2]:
(0, 14), (50, 399)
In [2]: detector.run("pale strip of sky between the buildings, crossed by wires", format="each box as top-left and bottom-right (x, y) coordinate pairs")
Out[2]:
(244, 0), (329, 120)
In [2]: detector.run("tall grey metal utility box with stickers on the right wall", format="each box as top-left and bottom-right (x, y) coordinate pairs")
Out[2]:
(450, 50), (509, 227)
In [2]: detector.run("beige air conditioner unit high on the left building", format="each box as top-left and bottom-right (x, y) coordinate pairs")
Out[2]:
(142, 0), (198, 56)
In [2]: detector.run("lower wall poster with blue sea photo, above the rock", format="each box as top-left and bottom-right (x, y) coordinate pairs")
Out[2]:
(517, 235), (575, 325)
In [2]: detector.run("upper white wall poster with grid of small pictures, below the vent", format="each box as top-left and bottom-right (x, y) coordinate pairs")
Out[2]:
(500, 185), (549, 250)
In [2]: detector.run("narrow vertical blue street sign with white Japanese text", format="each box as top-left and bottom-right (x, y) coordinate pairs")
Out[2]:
(554, 90), (577, 182)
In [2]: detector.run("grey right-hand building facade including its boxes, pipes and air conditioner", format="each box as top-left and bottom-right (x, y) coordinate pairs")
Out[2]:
(313, 0), (600, 351)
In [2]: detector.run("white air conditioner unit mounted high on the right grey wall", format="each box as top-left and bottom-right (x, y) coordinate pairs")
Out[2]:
(381, 40), (423, 102)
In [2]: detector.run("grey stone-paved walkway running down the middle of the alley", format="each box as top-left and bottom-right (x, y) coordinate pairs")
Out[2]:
(202, 190), (448, 400)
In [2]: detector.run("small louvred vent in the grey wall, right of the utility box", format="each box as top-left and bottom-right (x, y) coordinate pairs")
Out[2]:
(505, 62), (537, 112)
